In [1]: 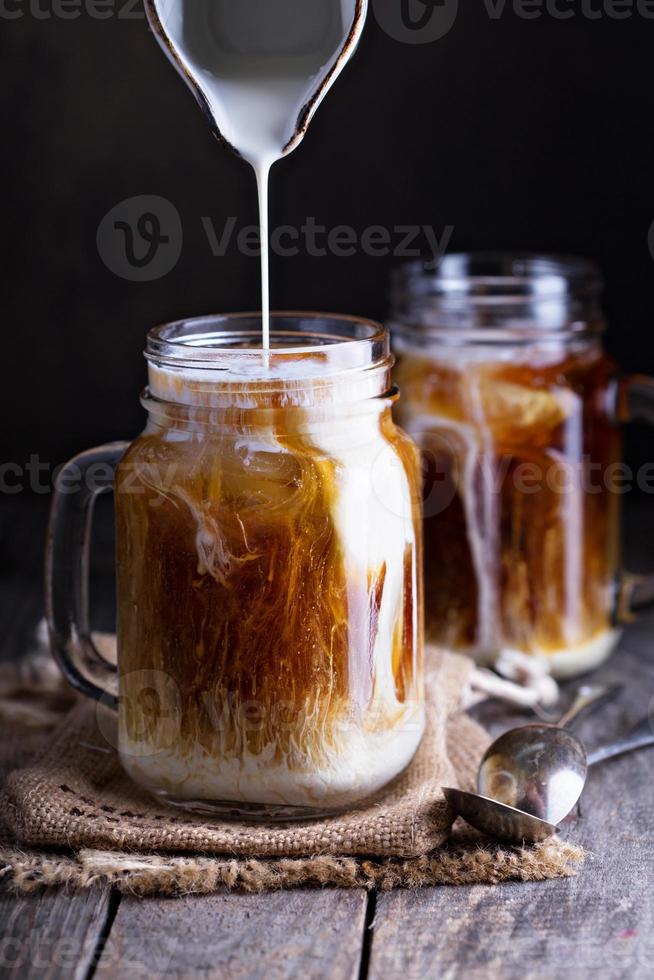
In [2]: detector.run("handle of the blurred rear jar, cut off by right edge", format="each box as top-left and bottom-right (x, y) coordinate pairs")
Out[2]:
(616, 374), (654, 623)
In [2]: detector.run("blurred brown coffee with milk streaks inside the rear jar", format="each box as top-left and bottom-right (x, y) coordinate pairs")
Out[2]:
(397, 348), (621, 655)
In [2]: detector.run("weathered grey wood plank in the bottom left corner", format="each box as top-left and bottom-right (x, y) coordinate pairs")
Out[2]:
(0, 888), (110, 980)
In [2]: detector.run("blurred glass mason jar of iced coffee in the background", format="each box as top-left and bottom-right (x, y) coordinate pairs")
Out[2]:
(391, 254), (654, 677)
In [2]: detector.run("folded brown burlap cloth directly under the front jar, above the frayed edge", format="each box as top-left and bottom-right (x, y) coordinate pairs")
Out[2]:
(0, 652), (488, 860)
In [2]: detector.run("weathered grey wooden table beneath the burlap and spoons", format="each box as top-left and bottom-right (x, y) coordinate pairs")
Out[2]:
(0, 501), (654, 980)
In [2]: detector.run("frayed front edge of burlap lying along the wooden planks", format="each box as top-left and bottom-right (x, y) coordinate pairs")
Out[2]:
(0, 838), (584, 897)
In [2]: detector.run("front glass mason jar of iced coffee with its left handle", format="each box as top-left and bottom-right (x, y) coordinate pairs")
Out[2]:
(48, 314), (424, 819)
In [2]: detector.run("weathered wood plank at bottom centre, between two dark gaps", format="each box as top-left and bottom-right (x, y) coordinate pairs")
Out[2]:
(97, 889), (367, 980)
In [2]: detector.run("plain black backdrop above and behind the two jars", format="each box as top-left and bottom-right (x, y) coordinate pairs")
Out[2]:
(0, 0), (654, 474)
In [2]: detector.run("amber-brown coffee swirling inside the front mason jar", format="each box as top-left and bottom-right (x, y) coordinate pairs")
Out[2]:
(116, 398), (421, 768)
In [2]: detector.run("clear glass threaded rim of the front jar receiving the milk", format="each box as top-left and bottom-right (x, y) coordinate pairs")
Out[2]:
(145, 312), (394, 408)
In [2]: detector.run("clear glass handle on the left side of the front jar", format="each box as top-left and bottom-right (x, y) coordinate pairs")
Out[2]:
(45, 442), (128, 708)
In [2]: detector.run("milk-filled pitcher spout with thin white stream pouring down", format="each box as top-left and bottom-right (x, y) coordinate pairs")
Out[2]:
(146, 0), (368, 348)
